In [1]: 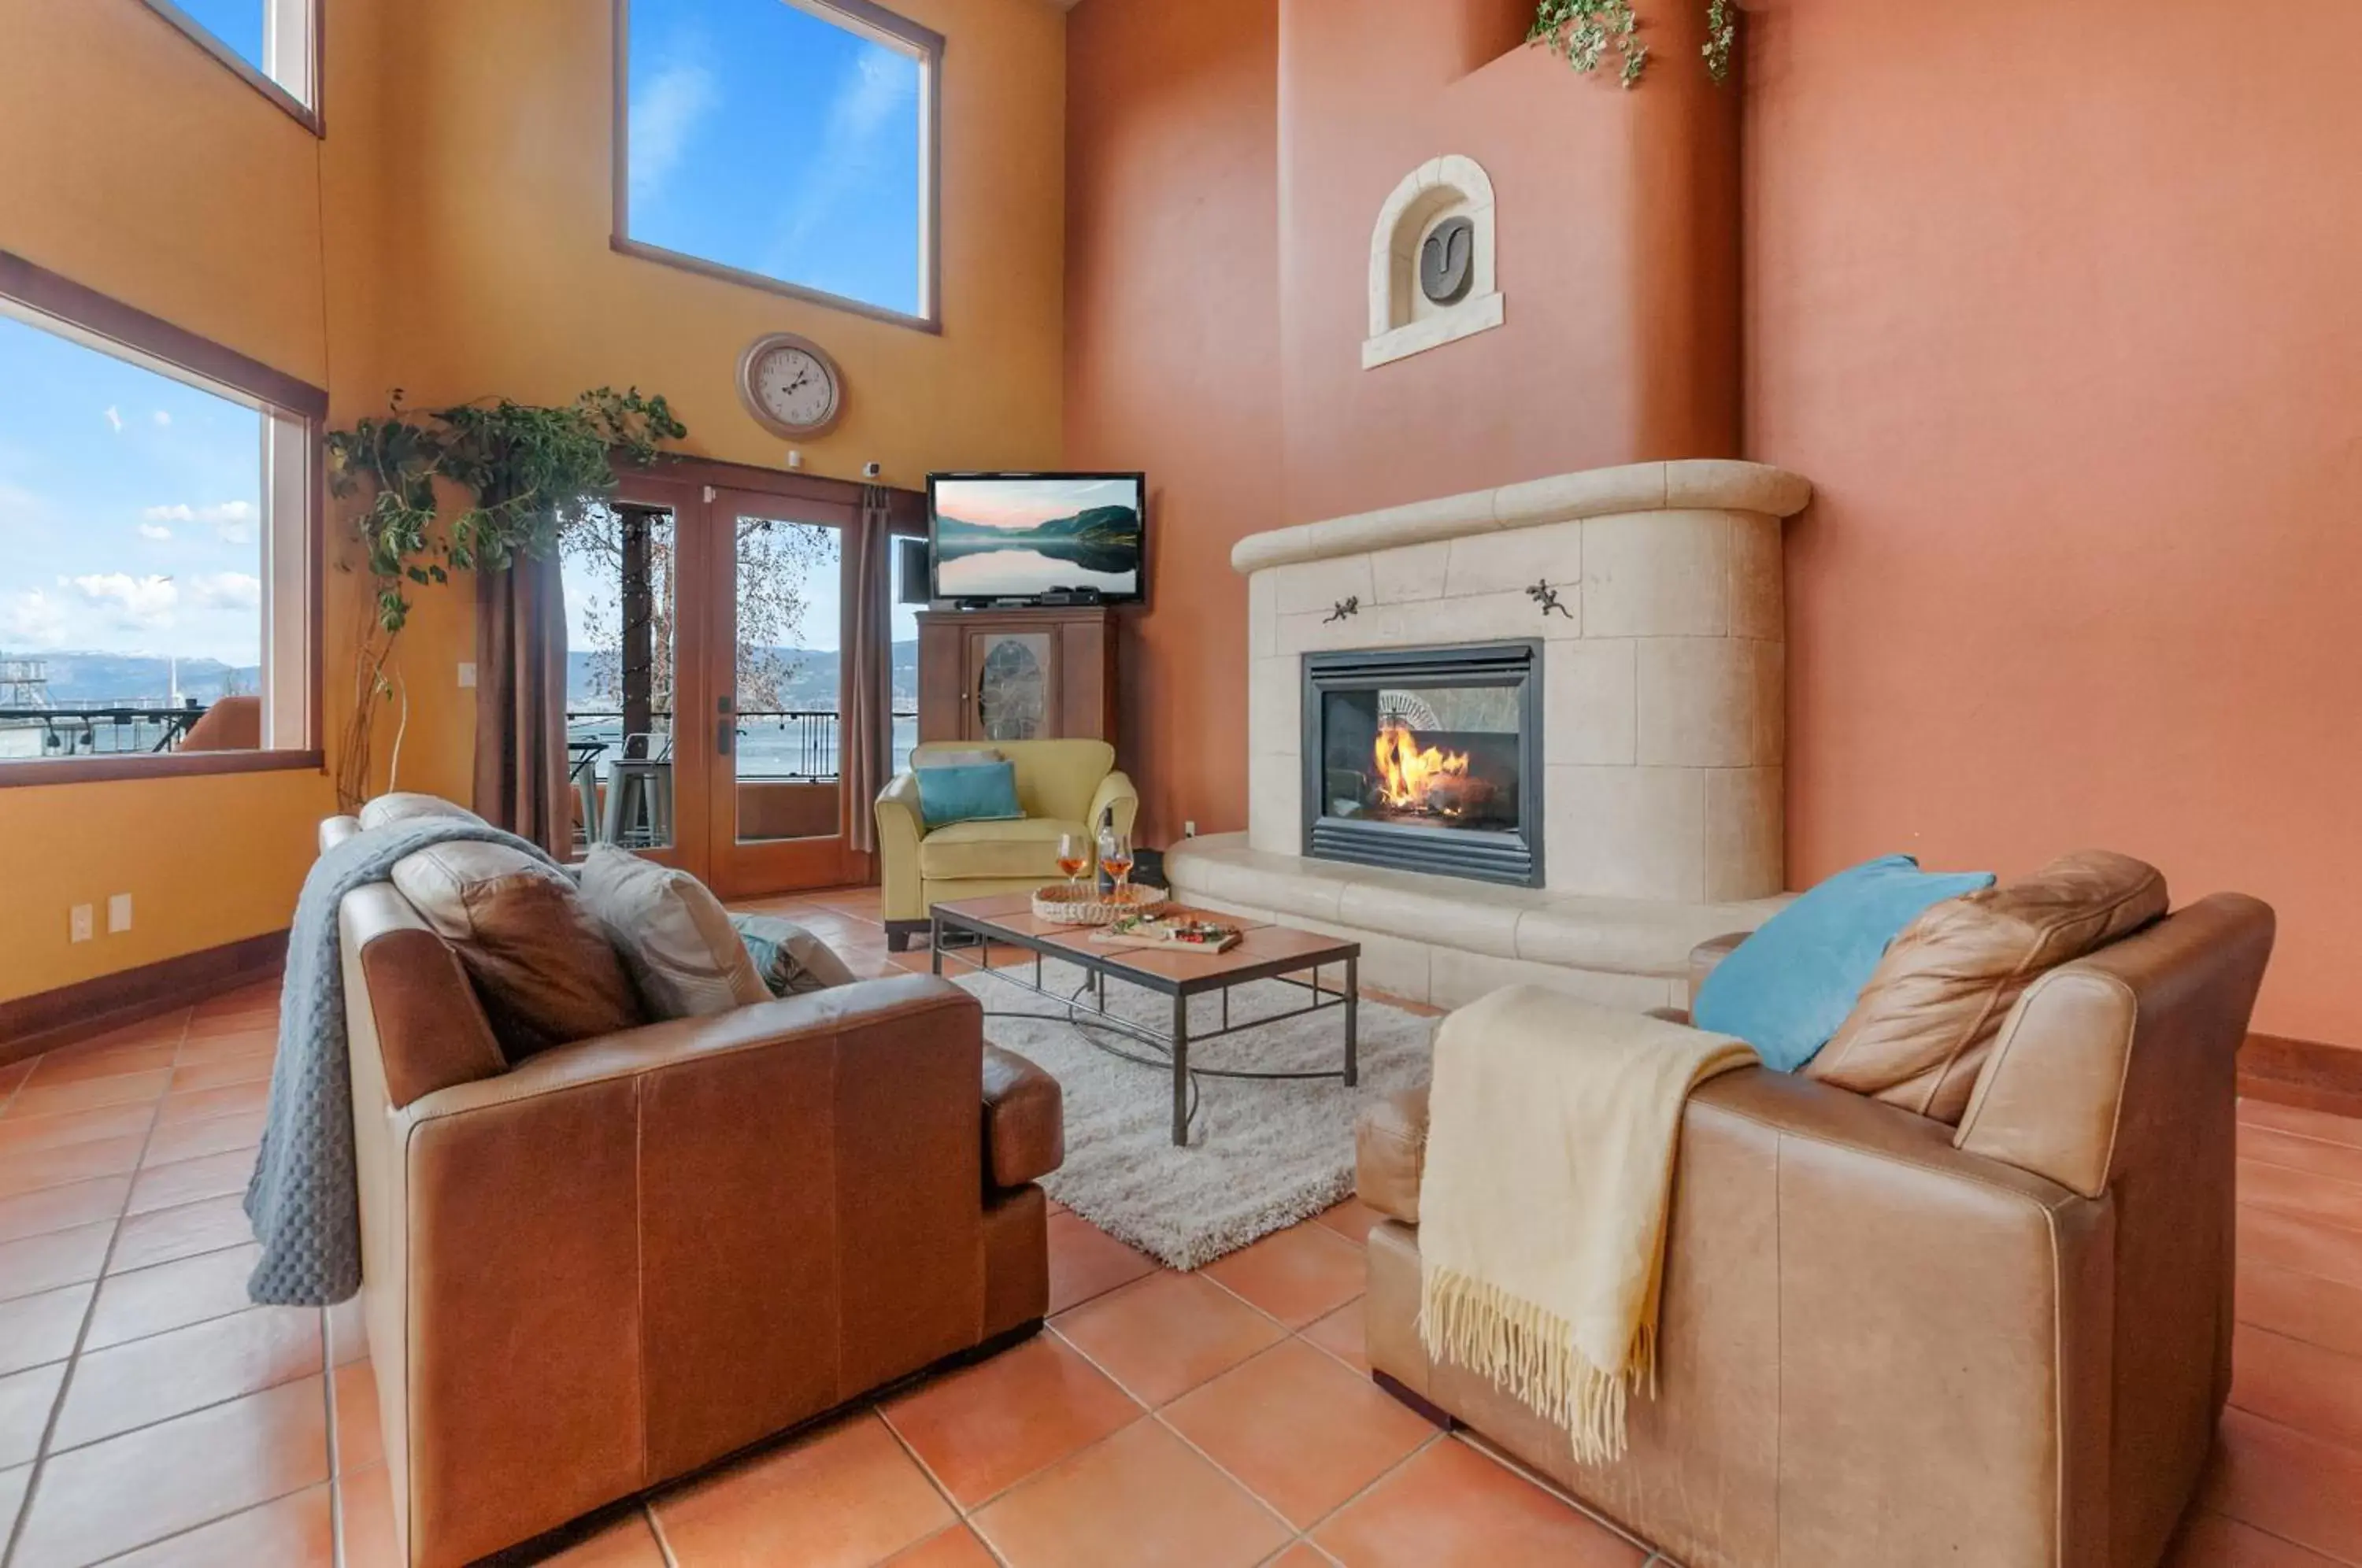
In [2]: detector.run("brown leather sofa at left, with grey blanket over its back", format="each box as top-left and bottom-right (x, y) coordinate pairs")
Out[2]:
(321, 819), (1063, 1568)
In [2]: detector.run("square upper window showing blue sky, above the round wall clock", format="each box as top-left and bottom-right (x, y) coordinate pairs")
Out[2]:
(614, 0), (942, 328)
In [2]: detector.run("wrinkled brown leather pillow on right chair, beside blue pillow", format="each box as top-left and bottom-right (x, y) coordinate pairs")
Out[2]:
(1805, 850), (2166, 1124)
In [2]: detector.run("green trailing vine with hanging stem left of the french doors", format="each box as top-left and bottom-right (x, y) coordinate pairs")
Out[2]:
(326, 387), (687, 810)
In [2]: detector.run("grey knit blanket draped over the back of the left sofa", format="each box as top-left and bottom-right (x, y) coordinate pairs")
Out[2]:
(246, 817), (557, 1306)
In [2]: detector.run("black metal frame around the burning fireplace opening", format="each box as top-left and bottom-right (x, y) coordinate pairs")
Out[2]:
(1301, 638), (1547, 888)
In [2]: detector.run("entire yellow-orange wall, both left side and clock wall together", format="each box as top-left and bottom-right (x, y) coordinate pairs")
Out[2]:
(0, 0), (1065, 999)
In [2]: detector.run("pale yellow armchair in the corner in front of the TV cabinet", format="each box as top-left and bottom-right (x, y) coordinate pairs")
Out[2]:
(876, 741), (1141, 952)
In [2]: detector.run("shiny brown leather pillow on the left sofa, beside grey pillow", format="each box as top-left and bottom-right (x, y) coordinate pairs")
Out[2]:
(394, 843), (647, 1063)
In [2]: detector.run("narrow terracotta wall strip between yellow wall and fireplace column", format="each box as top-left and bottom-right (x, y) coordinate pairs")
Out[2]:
(1063, 0), (1280, 843)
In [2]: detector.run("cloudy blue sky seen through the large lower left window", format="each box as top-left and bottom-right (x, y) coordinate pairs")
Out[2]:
(0, 314), (262, 666)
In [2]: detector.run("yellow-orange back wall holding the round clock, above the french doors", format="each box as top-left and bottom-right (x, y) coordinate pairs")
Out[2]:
(359, 0), (1065, 798)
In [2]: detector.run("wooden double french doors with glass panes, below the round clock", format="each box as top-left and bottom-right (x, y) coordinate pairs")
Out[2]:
(565, 470), (886, 897)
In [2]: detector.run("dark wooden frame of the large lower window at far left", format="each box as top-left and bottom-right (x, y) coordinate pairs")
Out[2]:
(0, 250), (328, 789)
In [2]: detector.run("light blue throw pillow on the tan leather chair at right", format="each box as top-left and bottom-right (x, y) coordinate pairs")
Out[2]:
(1689, 855), (1994, 1072)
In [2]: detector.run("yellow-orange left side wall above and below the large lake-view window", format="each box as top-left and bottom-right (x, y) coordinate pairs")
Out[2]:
(0, 0), (376, 999)
